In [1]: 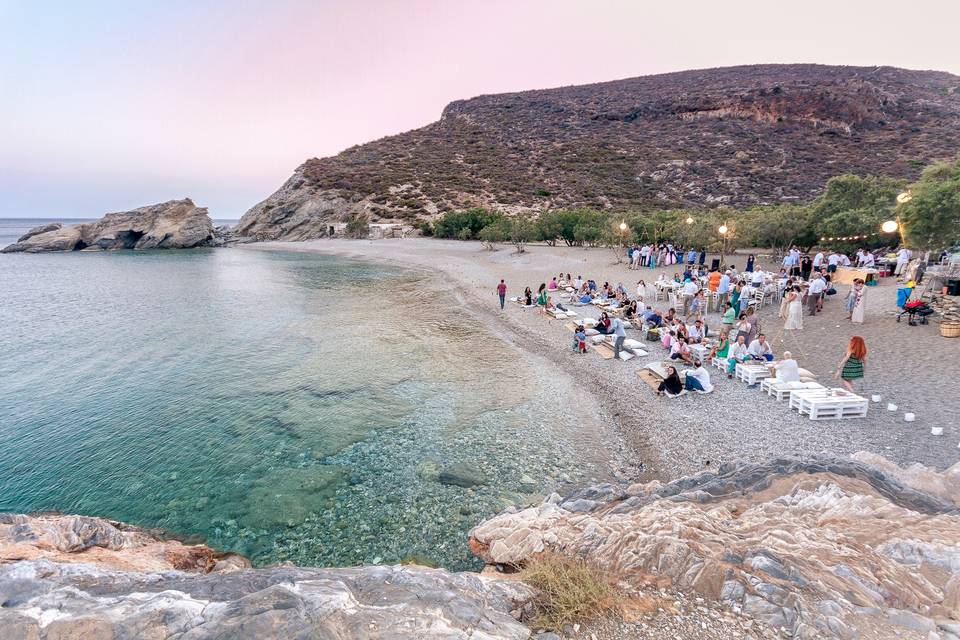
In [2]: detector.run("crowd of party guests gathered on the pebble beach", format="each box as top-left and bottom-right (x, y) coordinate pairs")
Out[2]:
(497, 244), (888, 395)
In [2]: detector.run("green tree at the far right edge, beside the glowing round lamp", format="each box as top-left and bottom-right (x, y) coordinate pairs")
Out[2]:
(897, 156), (960, 249)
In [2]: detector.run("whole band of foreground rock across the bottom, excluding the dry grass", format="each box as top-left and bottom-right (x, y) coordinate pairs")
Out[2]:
(0, 454), (960, 640)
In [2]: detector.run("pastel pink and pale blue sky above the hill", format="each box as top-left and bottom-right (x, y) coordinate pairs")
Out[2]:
(0, 0), (960, 218)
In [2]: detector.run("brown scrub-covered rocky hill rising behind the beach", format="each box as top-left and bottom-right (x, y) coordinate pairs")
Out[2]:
(239, 65), (960, 239)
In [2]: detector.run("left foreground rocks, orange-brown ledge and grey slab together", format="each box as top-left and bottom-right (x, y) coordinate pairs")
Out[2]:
(0, 514), (533, 640)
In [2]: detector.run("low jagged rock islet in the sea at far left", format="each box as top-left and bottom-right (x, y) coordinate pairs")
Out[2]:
(2, 198), (218, 253)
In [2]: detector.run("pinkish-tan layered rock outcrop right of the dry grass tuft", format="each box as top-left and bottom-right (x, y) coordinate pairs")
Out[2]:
(470, 458), (960, 640)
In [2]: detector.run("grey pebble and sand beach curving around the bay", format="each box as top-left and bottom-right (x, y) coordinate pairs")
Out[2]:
(247, 238), (960, 479)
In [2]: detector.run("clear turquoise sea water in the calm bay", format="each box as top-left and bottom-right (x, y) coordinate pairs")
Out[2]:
(0, 219), (609, 569)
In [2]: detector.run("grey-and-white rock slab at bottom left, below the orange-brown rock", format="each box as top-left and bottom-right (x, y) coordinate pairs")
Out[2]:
(0, 560), (531, 640)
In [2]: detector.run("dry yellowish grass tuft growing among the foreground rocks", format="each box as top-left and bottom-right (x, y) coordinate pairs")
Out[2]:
(521, 553), (624, 631)
